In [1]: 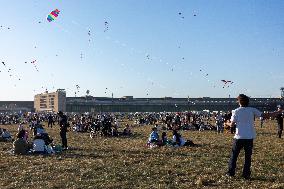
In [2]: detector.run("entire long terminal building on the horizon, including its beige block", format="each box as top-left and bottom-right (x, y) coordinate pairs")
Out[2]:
(0, 89), (284, 113)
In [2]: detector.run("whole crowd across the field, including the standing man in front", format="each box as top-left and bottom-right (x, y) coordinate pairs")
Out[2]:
(0, 94), (284, 179)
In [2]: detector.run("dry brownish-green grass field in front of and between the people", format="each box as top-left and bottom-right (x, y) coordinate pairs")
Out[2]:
(0, 121), (284, 189)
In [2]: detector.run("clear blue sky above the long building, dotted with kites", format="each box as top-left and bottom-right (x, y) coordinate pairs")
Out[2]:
(0, 0), (284, 100)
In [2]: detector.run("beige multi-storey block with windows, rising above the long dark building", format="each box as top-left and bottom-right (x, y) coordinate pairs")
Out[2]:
(34, 89), (66, 112)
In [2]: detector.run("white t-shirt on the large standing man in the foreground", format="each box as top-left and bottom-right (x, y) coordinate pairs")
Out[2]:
(231, 107), (262, 139)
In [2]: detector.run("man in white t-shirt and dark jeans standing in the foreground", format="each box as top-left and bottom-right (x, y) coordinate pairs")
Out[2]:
(227, 94), (281, 179)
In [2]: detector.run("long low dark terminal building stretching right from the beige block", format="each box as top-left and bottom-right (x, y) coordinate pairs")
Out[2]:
(66, 96), (284, 112)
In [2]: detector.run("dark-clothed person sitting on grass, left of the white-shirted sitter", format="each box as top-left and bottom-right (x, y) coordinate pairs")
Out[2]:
(13, 130), (29, 155)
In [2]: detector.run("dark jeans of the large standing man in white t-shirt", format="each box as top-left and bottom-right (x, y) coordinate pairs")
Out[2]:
(228, 139), (253, 178)
